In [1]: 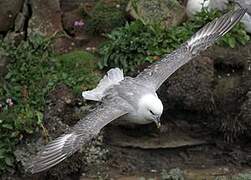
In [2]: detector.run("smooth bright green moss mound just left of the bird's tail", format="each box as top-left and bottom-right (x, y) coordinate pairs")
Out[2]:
(56, 51), (100, 93)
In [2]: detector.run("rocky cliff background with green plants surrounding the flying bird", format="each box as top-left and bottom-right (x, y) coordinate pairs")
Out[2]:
(0, 0), (251, 180)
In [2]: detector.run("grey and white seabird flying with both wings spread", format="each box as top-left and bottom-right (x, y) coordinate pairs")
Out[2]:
(28, 8), (246, 173)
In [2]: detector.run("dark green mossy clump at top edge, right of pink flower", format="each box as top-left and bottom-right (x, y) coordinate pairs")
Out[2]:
(86, 0), (126, 34)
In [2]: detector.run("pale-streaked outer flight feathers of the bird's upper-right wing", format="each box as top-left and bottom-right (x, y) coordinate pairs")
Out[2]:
(186, 8), (247, 55)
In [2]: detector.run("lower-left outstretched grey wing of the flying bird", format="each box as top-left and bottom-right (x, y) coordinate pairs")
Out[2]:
(28, 103), (127, 173)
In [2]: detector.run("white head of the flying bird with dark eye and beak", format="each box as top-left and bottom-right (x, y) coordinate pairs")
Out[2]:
(138, 94), (163, 127)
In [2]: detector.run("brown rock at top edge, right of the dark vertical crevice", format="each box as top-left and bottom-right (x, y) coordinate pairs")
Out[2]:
(28, 0), (63, 36)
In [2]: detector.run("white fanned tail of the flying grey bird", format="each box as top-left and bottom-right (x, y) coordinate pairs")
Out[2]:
(82, 68), (124, 101)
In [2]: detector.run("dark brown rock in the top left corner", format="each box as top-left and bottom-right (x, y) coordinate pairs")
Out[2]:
(0, 0), (23, 33)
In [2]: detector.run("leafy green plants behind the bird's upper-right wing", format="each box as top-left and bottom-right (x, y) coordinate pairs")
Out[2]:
(99, 9), (250, 74)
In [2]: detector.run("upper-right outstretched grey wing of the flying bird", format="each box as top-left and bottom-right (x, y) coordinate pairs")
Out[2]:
(136, 9), (246, 90)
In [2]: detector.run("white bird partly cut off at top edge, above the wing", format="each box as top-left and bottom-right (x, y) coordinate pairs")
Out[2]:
(186, 0), (229, 17)
